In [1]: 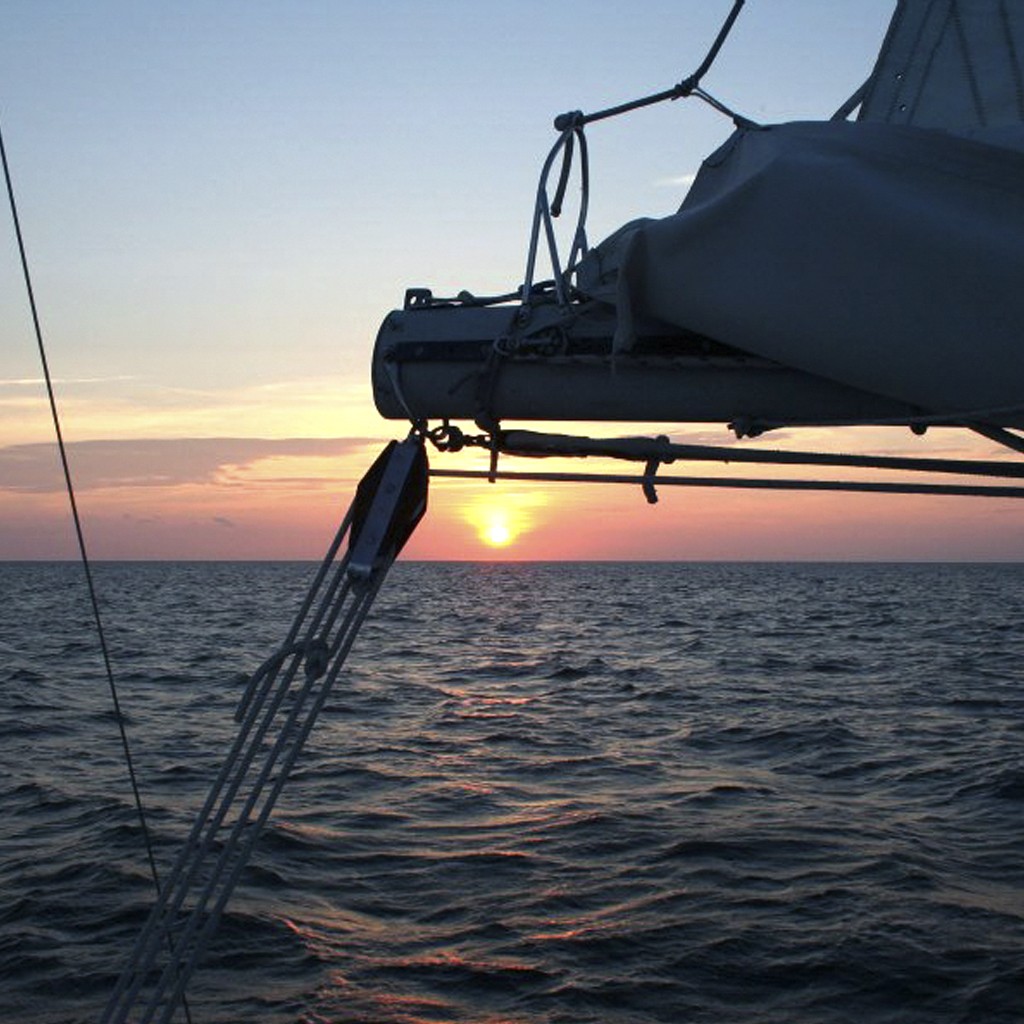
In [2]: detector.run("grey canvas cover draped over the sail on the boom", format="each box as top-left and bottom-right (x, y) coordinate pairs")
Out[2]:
(579, 121), (1024, 414)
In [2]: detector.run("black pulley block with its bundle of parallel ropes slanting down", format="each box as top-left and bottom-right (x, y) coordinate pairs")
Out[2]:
(101, 434), (427, 1024)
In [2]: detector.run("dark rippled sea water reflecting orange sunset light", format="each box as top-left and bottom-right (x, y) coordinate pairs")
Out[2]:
(0, 563), (1024, 1024)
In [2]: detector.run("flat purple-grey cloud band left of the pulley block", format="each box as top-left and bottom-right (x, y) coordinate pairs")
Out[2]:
(0, 437), (374, 493)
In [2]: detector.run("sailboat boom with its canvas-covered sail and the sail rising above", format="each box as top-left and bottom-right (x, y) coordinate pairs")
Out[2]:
(374, 0), (1024, 432)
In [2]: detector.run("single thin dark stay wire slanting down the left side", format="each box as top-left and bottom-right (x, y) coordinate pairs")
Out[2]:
(0, 114), (191, 1024)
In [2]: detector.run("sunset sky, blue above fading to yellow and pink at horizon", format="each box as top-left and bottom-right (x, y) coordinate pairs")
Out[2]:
(0, 0), (1024, 560)
